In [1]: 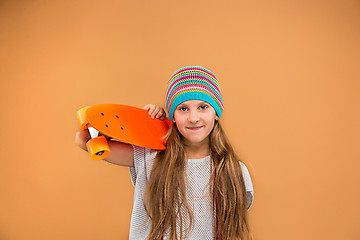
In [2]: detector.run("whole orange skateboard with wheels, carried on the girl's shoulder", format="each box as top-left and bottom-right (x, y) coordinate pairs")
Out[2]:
(76, 104), (172, 160)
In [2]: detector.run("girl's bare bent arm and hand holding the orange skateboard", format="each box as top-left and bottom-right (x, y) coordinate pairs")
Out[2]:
(75, 104), (166, 167)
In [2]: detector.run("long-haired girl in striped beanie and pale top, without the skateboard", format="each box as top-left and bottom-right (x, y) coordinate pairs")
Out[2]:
(76, 66), (253, 240)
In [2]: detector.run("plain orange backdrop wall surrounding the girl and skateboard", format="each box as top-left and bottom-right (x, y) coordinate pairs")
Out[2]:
(0, 0), (360, 240)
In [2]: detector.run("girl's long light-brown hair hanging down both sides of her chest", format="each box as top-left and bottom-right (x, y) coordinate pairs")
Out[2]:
(144, 121), (252, 240)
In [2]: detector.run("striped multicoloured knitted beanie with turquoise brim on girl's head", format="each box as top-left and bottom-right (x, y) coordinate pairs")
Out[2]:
(166, 66), (224, 121)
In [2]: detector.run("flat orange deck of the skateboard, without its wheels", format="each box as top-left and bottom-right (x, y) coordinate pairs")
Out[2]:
(86, 104), (172, 150)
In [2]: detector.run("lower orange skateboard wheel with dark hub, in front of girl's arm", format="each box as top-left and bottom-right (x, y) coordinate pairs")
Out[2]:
(86, 137), (110, 160)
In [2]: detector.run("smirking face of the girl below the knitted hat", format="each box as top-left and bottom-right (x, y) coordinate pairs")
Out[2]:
(173, 100), (219, 145)
